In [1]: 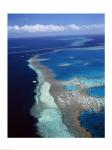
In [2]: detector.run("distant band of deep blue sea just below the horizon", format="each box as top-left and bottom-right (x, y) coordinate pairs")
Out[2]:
(8, 35), (104, 52)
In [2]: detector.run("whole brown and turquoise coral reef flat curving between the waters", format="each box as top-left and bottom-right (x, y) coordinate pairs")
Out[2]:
(29, 56), (104, 137)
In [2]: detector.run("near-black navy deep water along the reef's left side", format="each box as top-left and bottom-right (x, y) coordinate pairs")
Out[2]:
(8, 54), (41, 137)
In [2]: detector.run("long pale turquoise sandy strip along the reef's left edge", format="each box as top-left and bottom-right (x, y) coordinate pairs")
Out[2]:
(29, 60), (73, 137)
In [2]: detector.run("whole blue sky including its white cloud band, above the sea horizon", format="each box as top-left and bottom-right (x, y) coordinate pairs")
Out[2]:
(8, 14), (104, 38)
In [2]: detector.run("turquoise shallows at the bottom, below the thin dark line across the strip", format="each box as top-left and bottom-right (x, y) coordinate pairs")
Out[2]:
(37, 109), (72, 138)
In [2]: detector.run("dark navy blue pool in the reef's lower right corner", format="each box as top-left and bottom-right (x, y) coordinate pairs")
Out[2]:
(80, 111), (105, 137)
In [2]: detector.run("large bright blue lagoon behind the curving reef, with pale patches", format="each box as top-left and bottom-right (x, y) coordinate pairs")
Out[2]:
(40, 49), (104, 80)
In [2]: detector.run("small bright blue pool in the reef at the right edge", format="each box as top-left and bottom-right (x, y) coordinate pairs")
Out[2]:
(87, 86), (105, 97)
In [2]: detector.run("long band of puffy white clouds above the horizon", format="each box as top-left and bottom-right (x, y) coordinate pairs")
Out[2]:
(8, 24), (104, 33)
